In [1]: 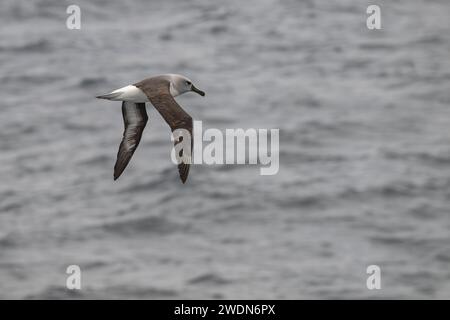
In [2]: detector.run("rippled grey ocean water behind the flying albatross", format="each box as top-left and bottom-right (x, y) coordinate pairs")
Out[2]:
(0, 0), (450, 299)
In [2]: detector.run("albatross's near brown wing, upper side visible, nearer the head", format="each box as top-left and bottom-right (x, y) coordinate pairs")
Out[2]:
(135, 78), (194, 183)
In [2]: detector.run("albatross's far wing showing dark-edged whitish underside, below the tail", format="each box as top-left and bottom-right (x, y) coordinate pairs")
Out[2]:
(114, 101), (148, 180)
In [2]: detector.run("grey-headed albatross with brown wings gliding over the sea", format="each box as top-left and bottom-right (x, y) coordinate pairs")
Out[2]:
(97, 74), (205, 183)
